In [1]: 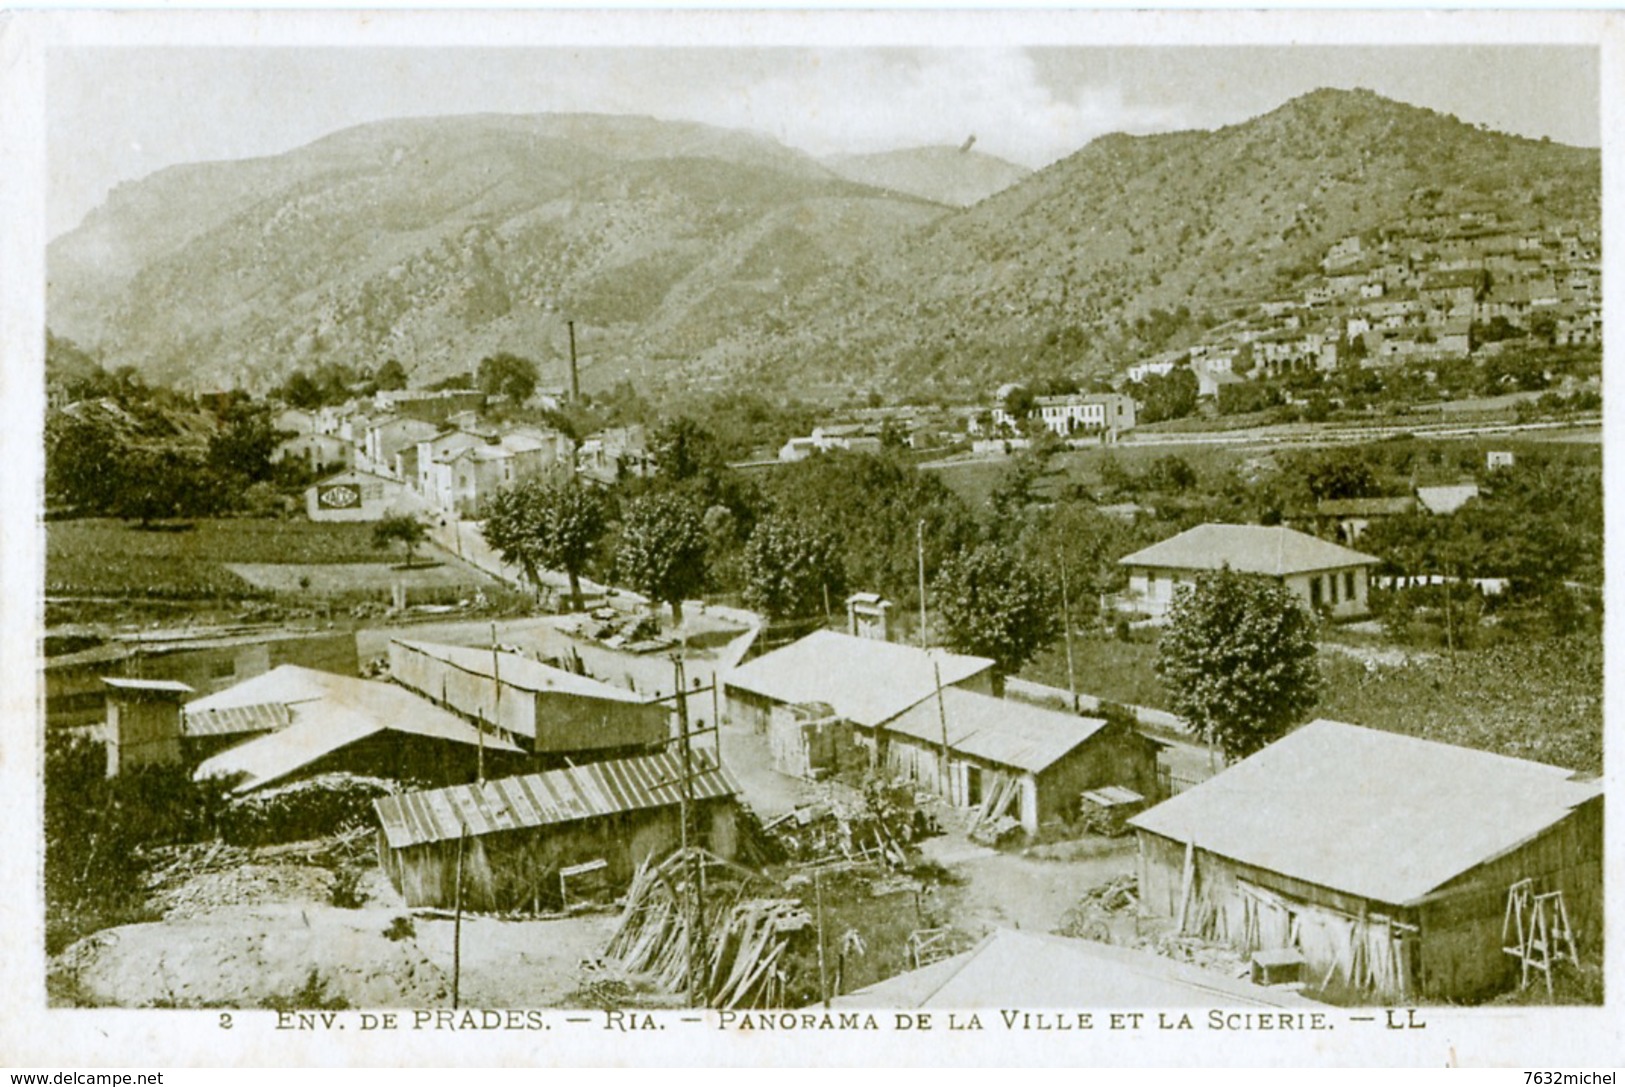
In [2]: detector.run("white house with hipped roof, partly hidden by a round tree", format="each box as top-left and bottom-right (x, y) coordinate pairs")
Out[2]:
(1118, 523), (1378, 619)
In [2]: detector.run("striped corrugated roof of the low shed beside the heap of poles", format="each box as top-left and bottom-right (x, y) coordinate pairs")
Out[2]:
(374, 751), (739, 850)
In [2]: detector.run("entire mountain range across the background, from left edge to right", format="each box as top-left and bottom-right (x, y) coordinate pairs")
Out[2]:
(47, 91), (1601, 395)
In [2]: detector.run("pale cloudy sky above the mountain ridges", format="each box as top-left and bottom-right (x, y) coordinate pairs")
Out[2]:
(46, 45), (1601, 237)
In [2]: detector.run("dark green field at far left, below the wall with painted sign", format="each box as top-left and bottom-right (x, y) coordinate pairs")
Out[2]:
(46, 518), (395, 600)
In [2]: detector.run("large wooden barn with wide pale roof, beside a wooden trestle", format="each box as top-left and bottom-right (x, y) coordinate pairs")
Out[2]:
(1129, 720), (1602, 1001)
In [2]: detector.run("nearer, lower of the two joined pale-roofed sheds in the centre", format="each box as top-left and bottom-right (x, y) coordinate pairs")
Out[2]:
(861, 687), (1162, 834)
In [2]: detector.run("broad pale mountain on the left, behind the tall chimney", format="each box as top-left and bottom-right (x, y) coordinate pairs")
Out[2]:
(47, 114), (946, 388)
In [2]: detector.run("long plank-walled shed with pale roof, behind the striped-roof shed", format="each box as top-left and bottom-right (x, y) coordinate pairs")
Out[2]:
(390, 639), (673, 762)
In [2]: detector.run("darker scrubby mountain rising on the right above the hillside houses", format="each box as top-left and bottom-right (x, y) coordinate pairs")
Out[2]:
(694, 89), (1601, 393)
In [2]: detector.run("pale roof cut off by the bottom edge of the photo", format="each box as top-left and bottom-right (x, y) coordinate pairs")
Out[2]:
(830, 929), (1318, 1009)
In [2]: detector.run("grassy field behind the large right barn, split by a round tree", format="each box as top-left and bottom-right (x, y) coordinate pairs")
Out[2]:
(1022, 623), (1602, 773)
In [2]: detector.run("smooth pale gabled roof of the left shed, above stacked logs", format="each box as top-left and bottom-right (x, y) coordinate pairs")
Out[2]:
(187, 665), (520, 793)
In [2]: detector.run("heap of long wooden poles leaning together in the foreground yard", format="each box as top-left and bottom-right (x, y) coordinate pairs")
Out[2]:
(605, 850), (813, 1007)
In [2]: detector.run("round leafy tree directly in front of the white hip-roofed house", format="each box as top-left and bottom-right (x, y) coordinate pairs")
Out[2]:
(1155, 569), (1320, 760)
